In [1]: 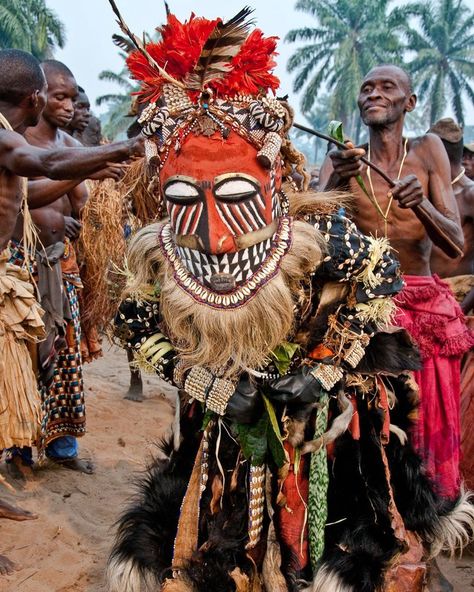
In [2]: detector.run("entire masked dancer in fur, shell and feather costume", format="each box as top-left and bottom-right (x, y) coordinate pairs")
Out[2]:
(109, 5), (474, 592)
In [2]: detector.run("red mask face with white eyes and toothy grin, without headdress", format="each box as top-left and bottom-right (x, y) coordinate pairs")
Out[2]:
(159, 115), (291, 306)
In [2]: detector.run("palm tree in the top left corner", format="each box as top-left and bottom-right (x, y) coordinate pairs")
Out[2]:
(0, 0), (65, 60)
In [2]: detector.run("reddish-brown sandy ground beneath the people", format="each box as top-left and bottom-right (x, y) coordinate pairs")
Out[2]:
(0, 348), (474, 592)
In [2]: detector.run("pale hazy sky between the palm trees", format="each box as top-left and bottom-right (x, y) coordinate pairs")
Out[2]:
(46, 0), (474, 124)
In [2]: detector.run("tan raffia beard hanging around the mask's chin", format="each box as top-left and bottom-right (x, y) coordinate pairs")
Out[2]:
(128, 221), (324, 379)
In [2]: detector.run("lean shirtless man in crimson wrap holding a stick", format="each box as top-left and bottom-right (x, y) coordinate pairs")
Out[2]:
(320, 66), (472, 591)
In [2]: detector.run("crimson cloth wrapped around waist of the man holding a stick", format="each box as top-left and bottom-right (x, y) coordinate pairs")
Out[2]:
(396, 275), (474, 498)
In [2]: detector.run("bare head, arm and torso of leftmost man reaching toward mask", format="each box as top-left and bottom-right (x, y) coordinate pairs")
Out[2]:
(0, 49), (143, 574)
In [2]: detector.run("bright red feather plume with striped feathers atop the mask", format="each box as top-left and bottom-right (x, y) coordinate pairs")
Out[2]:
(127, 9), (279, 102)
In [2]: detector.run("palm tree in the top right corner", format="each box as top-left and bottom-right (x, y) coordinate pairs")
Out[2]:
(406, 0), (474, 125)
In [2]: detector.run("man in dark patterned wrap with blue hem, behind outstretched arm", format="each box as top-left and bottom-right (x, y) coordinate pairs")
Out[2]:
(14, 60), (129, 473)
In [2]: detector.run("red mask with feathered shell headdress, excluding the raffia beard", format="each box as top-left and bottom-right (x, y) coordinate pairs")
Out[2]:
(127, 9), (291, 306)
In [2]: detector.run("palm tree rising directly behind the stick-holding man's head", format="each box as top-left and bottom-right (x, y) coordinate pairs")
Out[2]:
(286, 0), (410, 140)
